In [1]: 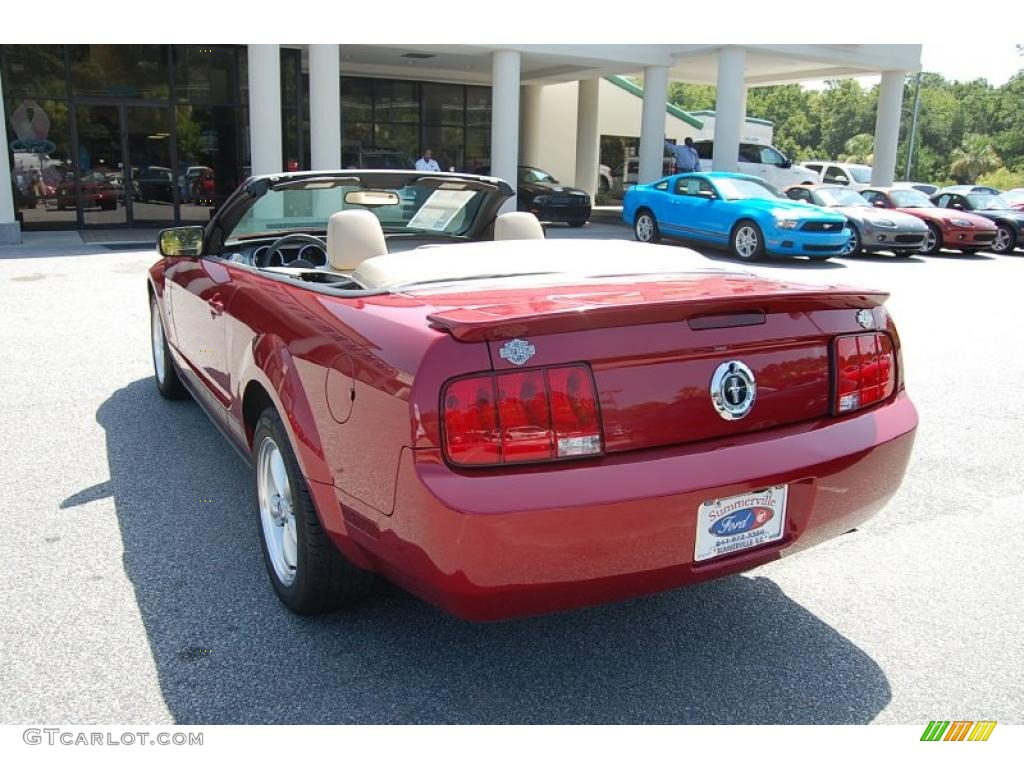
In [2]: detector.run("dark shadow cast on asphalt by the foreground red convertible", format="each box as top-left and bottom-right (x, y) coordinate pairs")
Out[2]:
(70, 379), (891, 723)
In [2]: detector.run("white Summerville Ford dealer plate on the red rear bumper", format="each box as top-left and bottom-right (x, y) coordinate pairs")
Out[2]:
(693, 485), (788, 562)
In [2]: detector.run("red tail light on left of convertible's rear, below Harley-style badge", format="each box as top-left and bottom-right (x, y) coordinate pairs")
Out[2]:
(441, 365), (603, 466)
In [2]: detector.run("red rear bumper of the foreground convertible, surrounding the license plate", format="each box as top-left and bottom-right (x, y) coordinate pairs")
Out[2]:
(322, 393), (918, 621)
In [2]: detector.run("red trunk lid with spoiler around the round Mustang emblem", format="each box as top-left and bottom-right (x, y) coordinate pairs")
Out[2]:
(428, 273), (887, 453)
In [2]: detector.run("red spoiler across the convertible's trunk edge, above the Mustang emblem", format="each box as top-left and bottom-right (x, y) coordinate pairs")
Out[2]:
(427, 288), (889, 342)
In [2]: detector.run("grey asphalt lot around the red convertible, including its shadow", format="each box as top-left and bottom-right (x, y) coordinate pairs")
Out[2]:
(0, 224), (1024, 724)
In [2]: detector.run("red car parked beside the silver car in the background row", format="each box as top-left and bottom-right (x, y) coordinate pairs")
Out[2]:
(860, 186), (996, 256)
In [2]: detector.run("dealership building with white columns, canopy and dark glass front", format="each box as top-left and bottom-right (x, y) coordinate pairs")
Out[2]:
(0, 44), (921, 243)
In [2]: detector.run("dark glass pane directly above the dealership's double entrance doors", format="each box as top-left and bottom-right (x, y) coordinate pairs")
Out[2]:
(68, 45), (170, 99)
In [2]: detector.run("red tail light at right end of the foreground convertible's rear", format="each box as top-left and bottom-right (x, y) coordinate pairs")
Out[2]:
(833, 333), (896, 414)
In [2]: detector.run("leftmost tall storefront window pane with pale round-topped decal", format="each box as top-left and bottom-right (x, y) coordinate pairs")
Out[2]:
(4, 97), (77, 229)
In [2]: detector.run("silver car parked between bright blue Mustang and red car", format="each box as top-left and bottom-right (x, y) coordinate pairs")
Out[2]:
(784, 184), (928, 256)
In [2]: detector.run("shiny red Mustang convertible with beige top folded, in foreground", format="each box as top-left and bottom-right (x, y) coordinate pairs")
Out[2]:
(148, 170), (918, 621)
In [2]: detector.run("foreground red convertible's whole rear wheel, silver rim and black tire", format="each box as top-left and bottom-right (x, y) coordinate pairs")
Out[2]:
(253, 408), (377, 614)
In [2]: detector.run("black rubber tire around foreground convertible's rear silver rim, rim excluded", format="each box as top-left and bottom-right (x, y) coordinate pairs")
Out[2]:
(253, 408), (379, 615)
